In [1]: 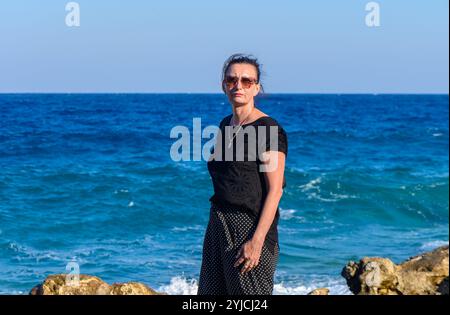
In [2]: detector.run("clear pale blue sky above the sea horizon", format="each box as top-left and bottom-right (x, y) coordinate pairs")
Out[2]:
(0, 0), (449, 93)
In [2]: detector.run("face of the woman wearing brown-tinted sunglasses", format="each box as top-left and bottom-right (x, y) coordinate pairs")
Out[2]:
(223, 63), (261, 105)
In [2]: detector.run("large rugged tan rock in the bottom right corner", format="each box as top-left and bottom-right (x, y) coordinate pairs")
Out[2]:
(341, 245), (449, 295)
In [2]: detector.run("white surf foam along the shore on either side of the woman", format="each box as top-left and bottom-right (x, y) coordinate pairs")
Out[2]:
(157, 276), (352, 295)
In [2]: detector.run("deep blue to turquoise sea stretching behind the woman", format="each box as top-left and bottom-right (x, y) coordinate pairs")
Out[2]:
(0, 94), (449, 294)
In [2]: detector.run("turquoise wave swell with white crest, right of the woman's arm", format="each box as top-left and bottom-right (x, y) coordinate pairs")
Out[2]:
(285, 169), (448, 225)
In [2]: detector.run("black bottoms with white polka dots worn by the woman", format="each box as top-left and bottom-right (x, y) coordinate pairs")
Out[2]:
(197, 204), (279, 295)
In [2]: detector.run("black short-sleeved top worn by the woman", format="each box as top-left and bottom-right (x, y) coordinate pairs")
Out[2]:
(207, 114), (288, 251)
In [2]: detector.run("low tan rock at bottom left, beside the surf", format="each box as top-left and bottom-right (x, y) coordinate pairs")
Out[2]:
(30, 274), (165, 295)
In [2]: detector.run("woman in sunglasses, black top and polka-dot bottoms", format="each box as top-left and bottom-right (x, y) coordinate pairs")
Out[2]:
(198, 54), (287, 295)
